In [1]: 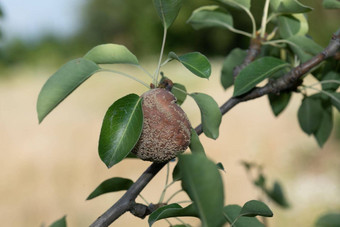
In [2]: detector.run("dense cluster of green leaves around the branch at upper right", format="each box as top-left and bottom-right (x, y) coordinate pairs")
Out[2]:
(188, 0), (340, 147)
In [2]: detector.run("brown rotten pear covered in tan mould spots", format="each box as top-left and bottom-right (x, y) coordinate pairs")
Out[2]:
(132, 80), (191, 162)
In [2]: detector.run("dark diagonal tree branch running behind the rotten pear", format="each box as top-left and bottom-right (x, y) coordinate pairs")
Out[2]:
(91, 29), (340, 227)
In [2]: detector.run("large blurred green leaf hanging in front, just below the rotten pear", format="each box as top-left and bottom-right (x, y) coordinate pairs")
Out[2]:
(178, 154), (224, 227)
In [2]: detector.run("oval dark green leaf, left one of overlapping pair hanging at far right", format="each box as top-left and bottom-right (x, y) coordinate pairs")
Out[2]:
(298, 97), (323, 135)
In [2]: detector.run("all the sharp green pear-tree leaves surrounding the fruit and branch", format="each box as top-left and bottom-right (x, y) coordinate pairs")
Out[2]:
(37, 0), (340, 227)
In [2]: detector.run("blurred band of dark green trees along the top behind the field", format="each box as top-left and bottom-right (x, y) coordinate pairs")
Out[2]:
(0, 0), (340, 71)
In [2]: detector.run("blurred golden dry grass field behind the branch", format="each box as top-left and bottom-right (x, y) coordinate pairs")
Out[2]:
(0, 61), (340, 227)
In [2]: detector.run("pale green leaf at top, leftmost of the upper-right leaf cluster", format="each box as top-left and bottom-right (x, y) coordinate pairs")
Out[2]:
(187, 5), (233, 29)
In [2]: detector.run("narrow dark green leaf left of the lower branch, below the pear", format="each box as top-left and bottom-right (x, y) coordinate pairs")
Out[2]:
(86, 177), (133, 200)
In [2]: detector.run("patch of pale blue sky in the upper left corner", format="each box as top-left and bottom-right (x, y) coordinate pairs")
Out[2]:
(0, 0), (82, 40)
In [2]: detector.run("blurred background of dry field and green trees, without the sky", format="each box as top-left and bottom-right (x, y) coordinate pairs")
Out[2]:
(0, 0), (340, 227)
